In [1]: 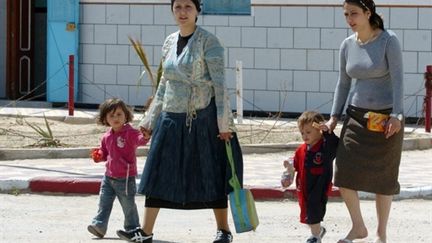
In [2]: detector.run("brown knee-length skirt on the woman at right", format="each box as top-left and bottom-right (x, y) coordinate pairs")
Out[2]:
(334, 106), (404, 195)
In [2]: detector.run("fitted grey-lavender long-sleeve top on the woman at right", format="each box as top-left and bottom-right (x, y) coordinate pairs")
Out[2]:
(331, 30), (403, 117)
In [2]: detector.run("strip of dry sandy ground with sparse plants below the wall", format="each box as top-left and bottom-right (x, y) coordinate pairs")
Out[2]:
(0, 116), (301, 148)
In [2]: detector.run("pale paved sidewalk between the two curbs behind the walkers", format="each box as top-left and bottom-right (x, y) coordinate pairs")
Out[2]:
(0, 149), (432, 198)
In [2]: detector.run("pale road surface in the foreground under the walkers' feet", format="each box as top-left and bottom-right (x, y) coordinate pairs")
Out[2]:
(0, 194), (432, 243)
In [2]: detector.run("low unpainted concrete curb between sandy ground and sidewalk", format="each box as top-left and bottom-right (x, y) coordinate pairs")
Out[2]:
(0, 137), (432, 160)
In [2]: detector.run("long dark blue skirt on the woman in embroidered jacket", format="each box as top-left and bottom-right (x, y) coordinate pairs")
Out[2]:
(138, 99), (243, 209)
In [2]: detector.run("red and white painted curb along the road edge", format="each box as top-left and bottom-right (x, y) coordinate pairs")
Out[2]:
(0, 177), (432, 200)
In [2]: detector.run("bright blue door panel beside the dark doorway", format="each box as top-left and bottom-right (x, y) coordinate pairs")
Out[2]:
(47, 0), (79, 102)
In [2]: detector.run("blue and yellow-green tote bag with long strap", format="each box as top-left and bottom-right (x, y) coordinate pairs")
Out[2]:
(225, 142), (259, 233)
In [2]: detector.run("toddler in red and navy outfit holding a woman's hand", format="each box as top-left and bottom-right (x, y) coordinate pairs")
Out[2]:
(284, 111), (339, 243)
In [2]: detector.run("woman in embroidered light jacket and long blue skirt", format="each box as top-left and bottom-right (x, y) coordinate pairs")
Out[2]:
(115, 0), (243, 242)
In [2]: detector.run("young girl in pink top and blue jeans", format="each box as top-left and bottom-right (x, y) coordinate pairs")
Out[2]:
(87, 98), (148, 238)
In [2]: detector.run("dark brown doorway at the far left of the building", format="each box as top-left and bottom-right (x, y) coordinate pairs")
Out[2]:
(5, 0), (47, 101)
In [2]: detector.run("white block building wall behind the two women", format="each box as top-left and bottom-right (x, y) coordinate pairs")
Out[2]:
(79, 0), (432, 117)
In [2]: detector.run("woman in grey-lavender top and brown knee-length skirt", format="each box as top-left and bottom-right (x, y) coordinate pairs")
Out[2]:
(327, 0), (404, 243)
